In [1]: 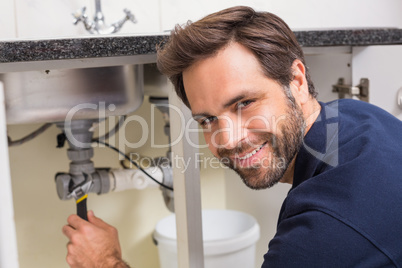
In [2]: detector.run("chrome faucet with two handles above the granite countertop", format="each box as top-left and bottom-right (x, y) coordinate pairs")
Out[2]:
(73, 0), (137, 34)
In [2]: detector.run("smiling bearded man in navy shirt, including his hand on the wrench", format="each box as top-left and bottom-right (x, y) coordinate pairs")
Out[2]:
(63, 7), (402, 267)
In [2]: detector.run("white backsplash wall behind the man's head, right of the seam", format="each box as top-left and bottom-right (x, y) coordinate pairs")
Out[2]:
(161, 0), (402, 30)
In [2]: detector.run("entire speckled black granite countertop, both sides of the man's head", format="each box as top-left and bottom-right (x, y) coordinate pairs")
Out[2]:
(0, 28), (402, 64)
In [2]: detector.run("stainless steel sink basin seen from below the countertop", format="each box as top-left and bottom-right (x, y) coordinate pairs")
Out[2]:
(0, 65), (144, 124)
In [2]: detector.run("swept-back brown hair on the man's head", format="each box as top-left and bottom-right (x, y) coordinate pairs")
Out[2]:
(157, 6), (317, 106)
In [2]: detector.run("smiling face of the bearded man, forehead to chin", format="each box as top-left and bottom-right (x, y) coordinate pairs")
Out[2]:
(183, 43), (305, 189)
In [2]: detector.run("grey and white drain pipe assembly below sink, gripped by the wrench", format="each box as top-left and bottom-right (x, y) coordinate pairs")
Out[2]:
(55, 119), (173, 213)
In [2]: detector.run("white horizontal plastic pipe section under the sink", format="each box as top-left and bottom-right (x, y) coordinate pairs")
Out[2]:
(110, 167), (163, 192)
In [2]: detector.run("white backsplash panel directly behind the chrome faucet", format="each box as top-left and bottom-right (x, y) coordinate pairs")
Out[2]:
(14, 0), (160, 38)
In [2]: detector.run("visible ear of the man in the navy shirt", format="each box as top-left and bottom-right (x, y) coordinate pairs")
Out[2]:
(290, 59), (310, 105)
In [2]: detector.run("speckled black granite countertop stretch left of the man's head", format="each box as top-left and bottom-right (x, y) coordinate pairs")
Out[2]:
(0, 35), (168, 63)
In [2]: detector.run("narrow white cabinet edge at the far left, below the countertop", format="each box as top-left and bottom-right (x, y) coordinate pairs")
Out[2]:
(0, 82), (19, 268)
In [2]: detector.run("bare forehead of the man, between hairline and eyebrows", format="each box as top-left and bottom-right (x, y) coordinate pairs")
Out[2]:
(182, 43), (265, 115)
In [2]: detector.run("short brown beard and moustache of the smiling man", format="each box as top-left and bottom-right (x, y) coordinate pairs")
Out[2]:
(217, 99), (306, 190)
